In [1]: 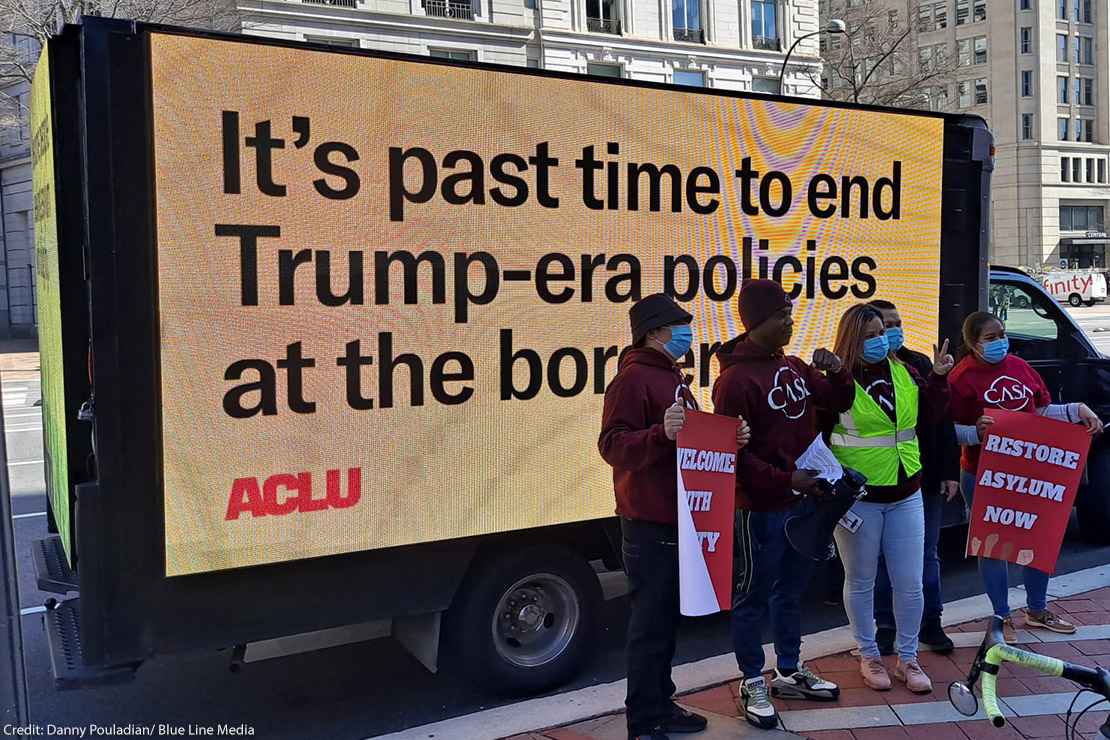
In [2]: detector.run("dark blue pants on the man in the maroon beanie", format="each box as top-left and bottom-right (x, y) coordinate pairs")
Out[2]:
(733, 510), (815, 678)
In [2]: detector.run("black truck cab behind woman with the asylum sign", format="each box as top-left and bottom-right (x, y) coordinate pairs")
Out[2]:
(990, 265), (1110, 545)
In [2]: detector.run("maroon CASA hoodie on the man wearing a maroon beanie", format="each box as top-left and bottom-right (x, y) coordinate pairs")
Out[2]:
(713, 335), (856, 511)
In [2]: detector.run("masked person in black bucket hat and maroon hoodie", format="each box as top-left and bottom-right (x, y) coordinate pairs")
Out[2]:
(597, 293), (749, 740)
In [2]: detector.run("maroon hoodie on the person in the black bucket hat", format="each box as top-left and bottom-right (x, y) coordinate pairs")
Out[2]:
(597, 347), (692, 525)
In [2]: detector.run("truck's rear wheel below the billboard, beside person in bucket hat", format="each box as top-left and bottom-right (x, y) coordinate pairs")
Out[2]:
(445, 546), (602, 695)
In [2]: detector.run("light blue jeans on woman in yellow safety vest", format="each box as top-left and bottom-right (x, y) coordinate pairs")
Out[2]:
(834, 491), (925, 661)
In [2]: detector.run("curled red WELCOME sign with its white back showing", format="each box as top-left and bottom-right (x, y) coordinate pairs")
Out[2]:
(677, 409), (739, 617)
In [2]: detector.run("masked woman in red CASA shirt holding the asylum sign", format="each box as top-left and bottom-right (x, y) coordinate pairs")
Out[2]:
(948, 311), (1102, 641)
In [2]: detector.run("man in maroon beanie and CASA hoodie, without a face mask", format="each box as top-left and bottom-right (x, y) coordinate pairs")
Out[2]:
(713, 280), (855, 729)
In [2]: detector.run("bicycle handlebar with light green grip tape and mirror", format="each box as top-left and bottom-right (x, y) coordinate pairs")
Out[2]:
(968, 616), (1110, 728)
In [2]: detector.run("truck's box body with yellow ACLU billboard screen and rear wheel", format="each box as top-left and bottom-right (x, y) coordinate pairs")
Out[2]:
(33, 18), (991, 691)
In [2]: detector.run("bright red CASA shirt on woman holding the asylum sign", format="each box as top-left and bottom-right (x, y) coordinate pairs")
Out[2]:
(948, 355), (1052, 473)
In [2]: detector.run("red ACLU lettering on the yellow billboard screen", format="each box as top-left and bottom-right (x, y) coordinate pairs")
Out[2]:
(224, 468), (362, 521)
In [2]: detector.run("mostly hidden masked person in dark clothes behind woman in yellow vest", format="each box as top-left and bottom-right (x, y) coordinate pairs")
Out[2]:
(868, 301), (960, 656)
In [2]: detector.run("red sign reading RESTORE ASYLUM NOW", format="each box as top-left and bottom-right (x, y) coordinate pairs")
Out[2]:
(967, 409), (1091, 574)
